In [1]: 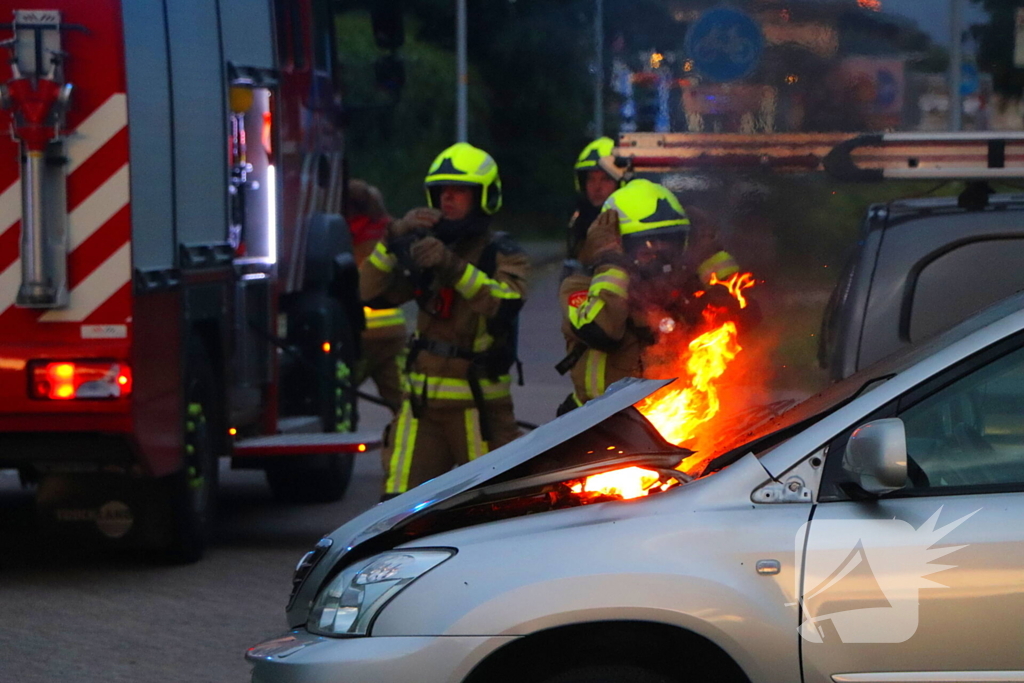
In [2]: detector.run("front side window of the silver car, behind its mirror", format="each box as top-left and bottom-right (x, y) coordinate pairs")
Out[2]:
(899, 348), (1024, 493)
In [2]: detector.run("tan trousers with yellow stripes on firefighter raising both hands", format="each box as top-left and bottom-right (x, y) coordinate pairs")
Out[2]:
(382, 396), (519, 499)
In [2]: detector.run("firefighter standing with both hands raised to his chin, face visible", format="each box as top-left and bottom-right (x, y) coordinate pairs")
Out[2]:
(359, 142), (529, 499)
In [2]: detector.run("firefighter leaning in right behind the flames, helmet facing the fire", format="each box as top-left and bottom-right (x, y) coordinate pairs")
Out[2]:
(558, 179), (739, 415)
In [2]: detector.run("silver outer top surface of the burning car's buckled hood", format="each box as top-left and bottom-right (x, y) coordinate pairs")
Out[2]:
(288, 378), (673, 625)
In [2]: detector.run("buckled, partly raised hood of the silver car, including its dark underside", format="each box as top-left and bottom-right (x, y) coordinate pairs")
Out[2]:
(288, 378), (675, 627)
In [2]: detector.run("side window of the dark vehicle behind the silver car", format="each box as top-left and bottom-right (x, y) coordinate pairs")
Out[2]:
(909, 239), (1024, 341)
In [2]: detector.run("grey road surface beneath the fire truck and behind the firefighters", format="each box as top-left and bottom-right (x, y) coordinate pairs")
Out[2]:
(0, 248), (569, 683)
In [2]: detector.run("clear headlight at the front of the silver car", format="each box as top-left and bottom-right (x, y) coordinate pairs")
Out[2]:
(306, 548), (455, 636)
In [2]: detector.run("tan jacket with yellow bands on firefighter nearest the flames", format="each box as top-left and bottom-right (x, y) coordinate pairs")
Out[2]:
(559, 244), (739, 405)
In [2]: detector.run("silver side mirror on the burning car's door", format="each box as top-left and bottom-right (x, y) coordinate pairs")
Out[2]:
(843, 418), (907, 496)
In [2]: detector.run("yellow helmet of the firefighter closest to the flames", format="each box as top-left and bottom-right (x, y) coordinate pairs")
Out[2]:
(601, 178), (690, 240)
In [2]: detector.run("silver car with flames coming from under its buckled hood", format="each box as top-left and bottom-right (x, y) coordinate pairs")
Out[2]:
(247, 296), (1024, 683)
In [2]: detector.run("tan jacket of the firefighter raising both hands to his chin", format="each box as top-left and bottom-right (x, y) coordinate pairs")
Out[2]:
(359, 231), (529, 408)
